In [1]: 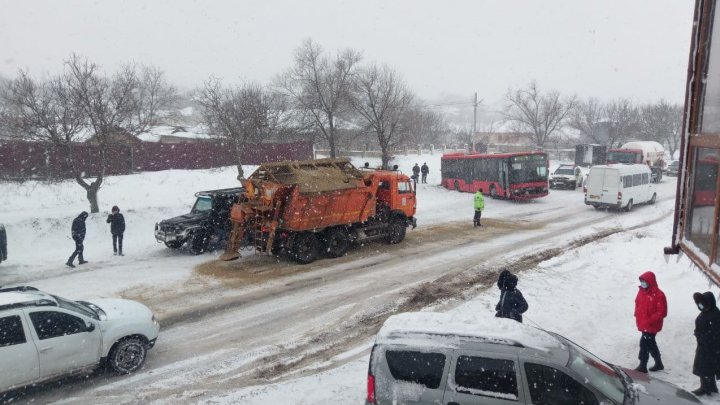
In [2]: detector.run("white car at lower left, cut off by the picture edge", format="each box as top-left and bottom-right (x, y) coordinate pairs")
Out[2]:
(0, 286), (160, 392)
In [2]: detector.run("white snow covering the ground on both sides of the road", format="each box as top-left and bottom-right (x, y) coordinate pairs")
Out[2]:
(0, 155), (720, 404)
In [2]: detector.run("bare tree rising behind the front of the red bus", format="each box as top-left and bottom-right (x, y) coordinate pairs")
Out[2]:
(504, 82), (576, 148)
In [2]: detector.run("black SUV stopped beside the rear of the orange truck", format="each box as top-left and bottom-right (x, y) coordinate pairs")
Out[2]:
(155, 187), (245, 255)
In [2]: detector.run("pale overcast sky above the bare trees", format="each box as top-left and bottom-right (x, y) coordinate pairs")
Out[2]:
(0, 0), (694, 103)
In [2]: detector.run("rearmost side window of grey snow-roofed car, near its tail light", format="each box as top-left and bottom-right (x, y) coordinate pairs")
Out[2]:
(385, 350), (445, 389)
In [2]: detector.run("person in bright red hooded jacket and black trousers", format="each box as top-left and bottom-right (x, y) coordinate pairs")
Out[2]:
(635, 271), (667, 373)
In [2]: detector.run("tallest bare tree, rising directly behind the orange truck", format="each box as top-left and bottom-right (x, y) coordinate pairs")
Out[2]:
(276, 39), (361, 157)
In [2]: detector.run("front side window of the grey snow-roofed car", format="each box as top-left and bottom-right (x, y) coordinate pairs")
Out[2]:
(525, 363), (598, 405)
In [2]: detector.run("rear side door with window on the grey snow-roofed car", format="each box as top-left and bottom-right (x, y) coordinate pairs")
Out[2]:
(442, 350), (525, 405)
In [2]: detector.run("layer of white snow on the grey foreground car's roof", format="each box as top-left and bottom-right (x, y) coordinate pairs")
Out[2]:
(377, 312), (563, 351)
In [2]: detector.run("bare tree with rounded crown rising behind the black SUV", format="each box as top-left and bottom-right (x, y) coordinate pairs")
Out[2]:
(196, 77), (286, 179)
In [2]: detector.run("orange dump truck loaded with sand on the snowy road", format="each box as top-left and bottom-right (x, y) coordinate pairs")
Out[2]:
(221, 159), (416, 264)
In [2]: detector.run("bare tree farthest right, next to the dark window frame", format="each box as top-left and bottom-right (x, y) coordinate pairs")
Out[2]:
(639, 100), (682, 156)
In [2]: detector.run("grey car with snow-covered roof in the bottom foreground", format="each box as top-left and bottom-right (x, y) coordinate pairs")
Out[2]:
(365, 312), (700, 405)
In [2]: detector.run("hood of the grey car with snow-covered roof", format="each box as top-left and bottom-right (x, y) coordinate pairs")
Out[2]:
(623, 368), (701, 405)
